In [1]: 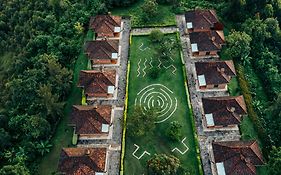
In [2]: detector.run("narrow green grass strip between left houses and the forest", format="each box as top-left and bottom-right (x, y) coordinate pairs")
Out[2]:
(38, 34), (89, 175)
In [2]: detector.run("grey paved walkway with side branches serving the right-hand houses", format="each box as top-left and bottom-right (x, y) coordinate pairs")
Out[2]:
(176, 15), (240, 175)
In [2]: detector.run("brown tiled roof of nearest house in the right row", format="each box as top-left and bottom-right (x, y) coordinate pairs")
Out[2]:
(212, 141), (264, 175)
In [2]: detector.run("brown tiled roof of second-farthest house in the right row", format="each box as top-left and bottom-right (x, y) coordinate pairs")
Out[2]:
(189, 31), (224, 52)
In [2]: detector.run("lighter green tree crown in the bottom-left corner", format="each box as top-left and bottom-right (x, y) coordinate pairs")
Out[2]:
(0, 164), (29, 175)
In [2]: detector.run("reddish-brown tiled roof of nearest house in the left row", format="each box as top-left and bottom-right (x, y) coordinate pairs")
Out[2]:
(58, 148), (106, 175)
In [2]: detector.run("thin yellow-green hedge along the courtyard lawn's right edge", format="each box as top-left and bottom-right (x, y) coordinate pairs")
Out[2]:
(182, 65), (204, 175)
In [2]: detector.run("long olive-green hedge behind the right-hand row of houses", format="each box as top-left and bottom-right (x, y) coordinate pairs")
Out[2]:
(235, 63), (271, 157)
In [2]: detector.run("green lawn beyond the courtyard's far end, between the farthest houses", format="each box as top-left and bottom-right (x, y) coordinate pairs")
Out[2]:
(112, 0), (176, 27)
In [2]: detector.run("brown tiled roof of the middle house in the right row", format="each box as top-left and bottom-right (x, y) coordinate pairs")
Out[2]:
(195, 60), (236, 85)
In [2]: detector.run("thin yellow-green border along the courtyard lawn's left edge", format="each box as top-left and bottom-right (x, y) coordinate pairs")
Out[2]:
(120, 61), (130, 175)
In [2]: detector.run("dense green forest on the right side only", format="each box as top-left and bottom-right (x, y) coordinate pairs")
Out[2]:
(221, 0), (281, 175)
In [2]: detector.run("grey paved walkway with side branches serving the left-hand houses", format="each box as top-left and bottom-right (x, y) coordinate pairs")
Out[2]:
(80, 19), (131, 175)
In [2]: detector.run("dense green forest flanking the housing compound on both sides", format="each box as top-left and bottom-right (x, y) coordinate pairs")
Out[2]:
(0, 0), (281, 175)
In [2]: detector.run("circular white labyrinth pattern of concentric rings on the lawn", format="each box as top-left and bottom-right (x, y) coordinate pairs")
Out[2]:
(135, 84), (178, 123)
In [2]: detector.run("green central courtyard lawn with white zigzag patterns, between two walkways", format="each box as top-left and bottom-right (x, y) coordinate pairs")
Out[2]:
(124, 34), (199, 175)
